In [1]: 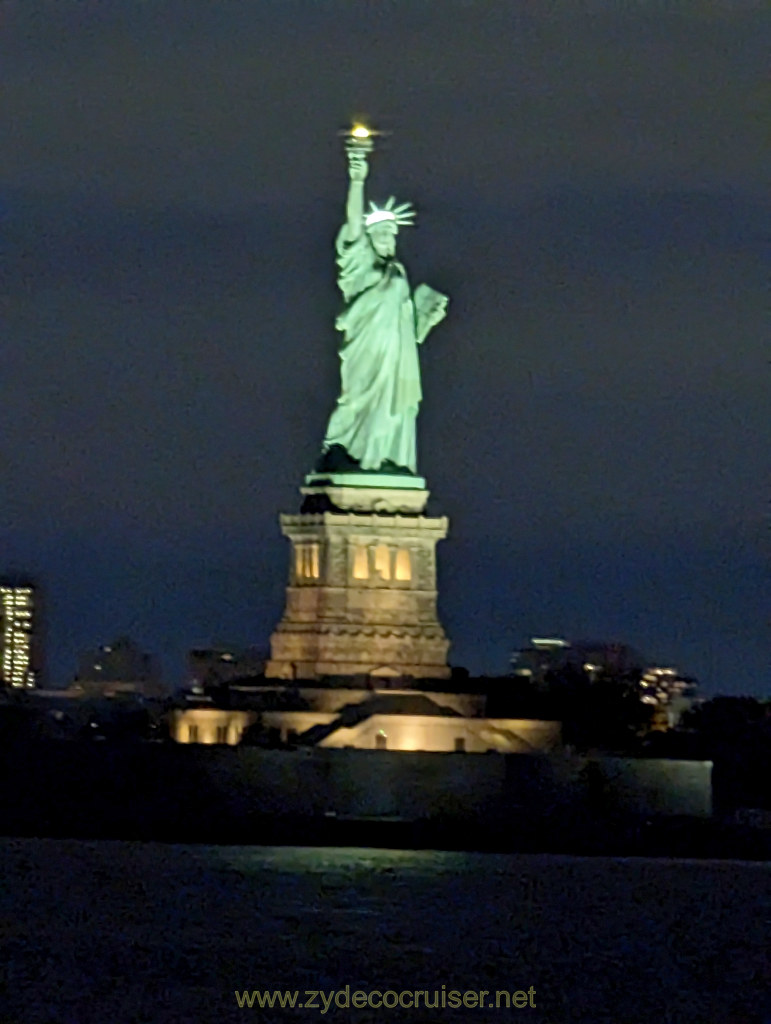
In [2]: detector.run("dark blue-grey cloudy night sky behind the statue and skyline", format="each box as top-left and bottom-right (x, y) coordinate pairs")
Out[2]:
(0, 0), (771, 693)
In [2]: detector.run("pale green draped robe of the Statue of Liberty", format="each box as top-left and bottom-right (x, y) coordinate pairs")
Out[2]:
(324, 228), (422, 473)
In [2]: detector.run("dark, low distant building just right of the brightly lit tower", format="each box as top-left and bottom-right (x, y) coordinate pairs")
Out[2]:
(73, 637), (163, 696)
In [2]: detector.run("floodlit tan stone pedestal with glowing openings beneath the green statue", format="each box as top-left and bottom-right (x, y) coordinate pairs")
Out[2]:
(265, 477), (449, 679)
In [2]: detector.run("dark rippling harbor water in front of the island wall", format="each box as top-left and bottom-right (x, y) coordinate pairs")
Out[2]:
(0, 839), (771, 1024)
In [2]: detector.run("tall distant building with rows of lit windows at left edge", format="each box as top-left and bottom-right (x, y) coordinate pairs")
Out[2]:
(0, 578), (42, 689)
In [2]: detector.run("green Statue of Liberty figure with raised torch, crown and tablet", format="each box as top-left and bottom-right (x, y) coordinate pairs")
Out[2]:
(316, 127), (447, 474)
